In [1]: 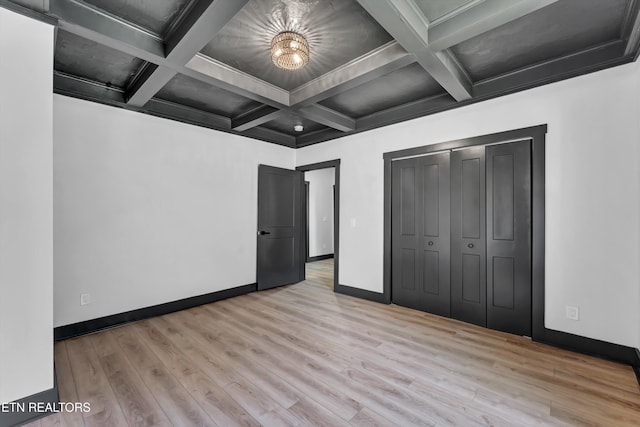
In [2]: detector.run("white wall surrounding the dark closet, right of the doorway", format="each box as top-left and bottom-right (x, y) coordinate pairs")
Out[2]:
(296, 63), (640, 347)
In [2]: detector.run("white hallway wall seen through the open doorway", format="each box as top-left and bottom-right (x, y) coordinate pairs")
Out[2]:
(304, 168), (335, 257)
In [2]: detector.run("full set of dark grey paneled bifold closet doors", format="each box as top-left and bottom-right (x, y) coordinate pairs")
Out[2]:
(391, 140), (532, 336)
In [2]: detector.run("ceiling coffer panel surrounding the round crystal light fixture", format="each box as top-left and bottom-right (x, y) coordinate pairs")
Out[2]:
(201, 0), (391, 90)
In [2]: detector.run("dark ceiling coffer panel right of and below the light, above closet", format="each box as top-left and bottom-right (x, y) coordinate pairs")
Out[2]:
(321, 64), (444, 118)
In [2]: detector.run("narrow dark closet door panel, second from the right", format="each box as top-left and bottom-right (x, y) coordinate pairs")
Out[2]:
(451, 146), (487, 326)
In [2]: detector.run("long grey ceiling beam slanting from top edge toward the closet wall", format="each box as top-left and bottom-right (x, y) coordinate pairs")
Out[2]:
(357, 0), (471, 101)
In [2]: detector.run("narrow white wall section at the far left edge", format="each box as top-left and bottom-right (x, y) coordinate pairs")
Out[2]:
(0, 8), (53, 402)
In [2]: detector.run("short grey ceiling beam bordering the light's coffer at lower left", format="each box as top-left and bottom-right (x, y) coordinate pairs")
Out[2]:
(180, 54), (289, 108)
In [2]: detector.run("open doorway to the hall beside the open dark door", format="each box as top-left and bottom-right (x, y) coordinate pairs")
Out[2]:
(296, 160), (340, 290)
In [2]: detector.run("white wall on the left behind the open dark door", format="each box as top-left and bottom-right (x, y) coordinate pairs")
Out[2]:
(54, 95), (295, 326)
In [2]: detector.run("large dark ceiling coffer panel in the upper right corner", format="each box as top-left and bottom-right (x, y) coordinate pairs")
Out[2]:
(452, 0), (628, 81)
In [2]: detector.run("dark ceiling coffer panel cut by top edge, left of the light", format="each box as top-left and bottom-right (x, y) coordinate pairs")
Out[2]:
(79, 0), (195, 36)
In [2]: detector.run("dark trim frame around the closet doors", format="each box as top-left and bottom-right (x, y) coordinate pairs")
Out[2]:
(383, 124), (548, 344)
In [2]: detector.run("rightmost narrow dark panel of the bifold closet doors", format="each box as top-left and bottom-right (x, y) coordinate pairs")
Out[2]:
(486, 141), (531, 336)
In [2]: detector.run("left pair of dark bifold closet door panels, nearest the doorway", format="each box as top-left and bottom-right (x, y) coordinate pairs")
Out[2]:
(391, 153), (451, 316)
